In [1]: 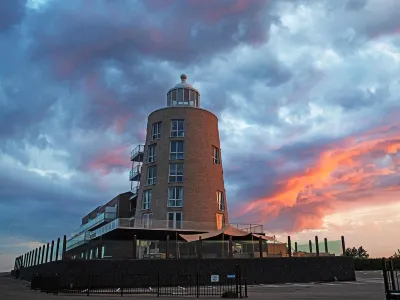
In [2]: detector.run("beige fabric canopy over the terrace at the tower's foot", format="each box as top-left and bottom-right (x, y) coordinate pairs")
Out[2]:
(179, 225), (275, 243)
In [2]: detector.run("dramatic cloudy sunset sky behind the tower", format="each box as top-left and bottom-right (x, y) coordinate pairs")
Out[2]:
(0, 0), (400, 270)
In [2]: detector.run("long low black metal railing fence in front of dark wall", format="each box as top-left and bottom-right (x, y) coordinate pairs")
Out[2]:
(31, 266), (247, 298)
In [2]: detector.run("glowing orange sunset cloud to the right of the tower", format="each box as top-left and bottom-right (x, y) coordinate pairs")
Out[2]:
(239, 126), (400, 231)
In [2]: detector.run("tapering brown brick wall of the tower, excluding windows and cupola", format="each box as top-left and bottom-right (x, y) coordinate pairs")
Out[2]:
(136, 107), (228, 230)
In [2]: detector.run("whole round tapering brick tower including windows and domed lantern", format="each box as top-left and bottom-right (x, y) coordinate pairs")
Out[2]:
(135, 75), (228, 230)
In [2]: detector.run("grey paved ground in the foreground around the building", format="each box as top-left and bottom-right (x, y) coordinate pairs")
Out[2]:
(0, 271), (385, 300)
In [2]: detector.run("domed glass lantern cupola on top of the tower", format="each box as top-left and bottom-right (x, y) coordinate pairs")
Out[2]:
(167, 74), (200, 107)
